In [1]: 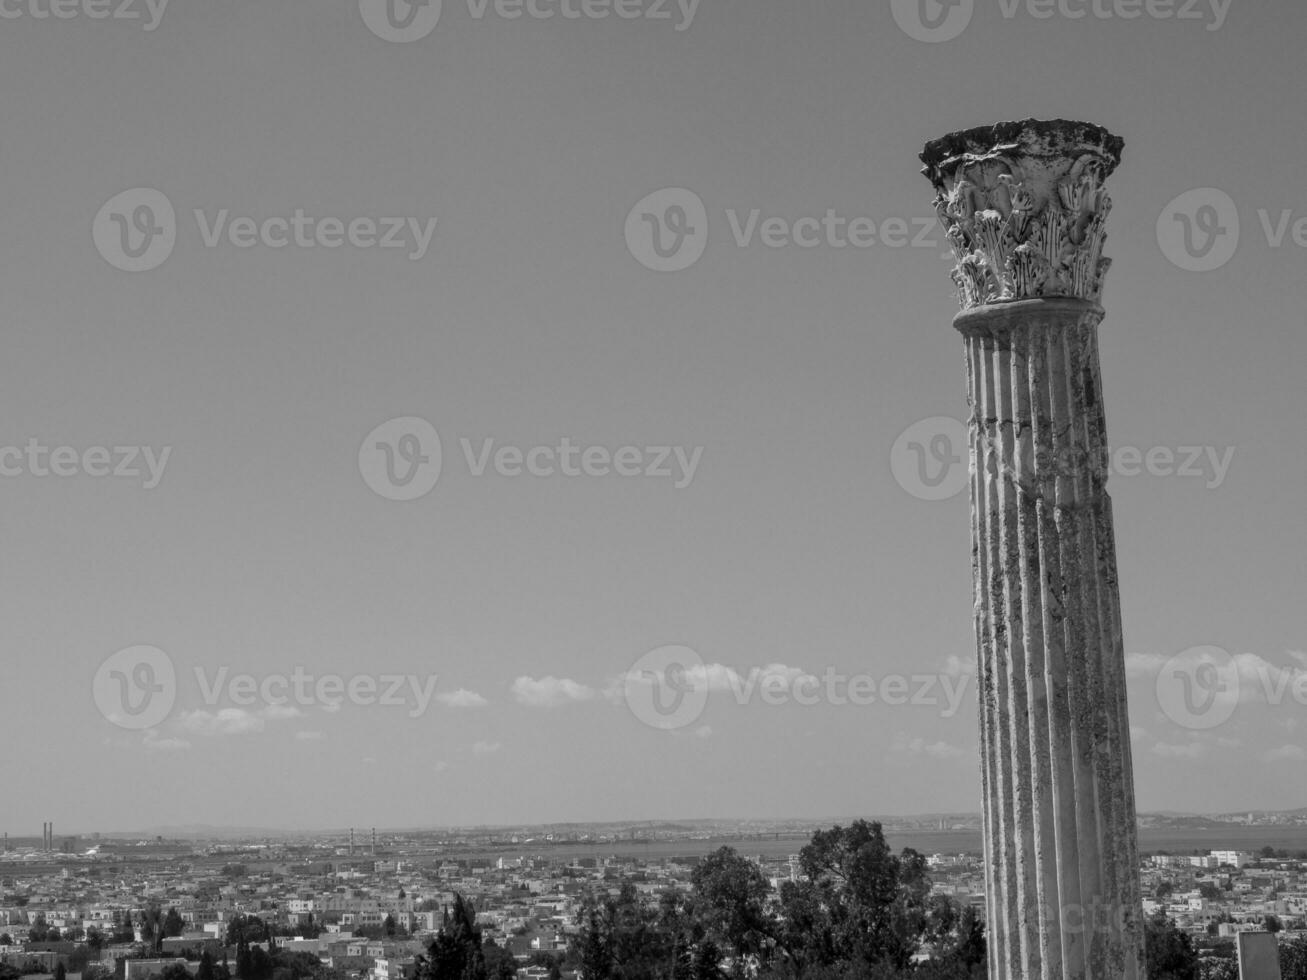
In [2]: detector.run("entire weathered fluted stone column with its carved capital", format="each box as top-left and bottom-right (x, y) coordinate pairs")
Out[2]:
(921, 120), (1145, 980)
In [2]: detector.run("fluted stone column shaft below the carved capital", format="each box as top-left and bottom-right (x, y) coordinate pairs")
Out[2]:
(955, 299), (1142, 980)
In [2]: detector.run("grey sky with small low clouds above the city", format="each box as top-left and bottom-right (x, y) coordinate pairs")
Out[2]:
(0, 0), (1307, 834)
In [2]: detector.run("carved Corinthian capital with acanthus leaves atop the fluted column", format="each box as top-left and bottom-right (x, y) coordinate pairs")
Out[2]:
(921, 119), (1124, 310)
